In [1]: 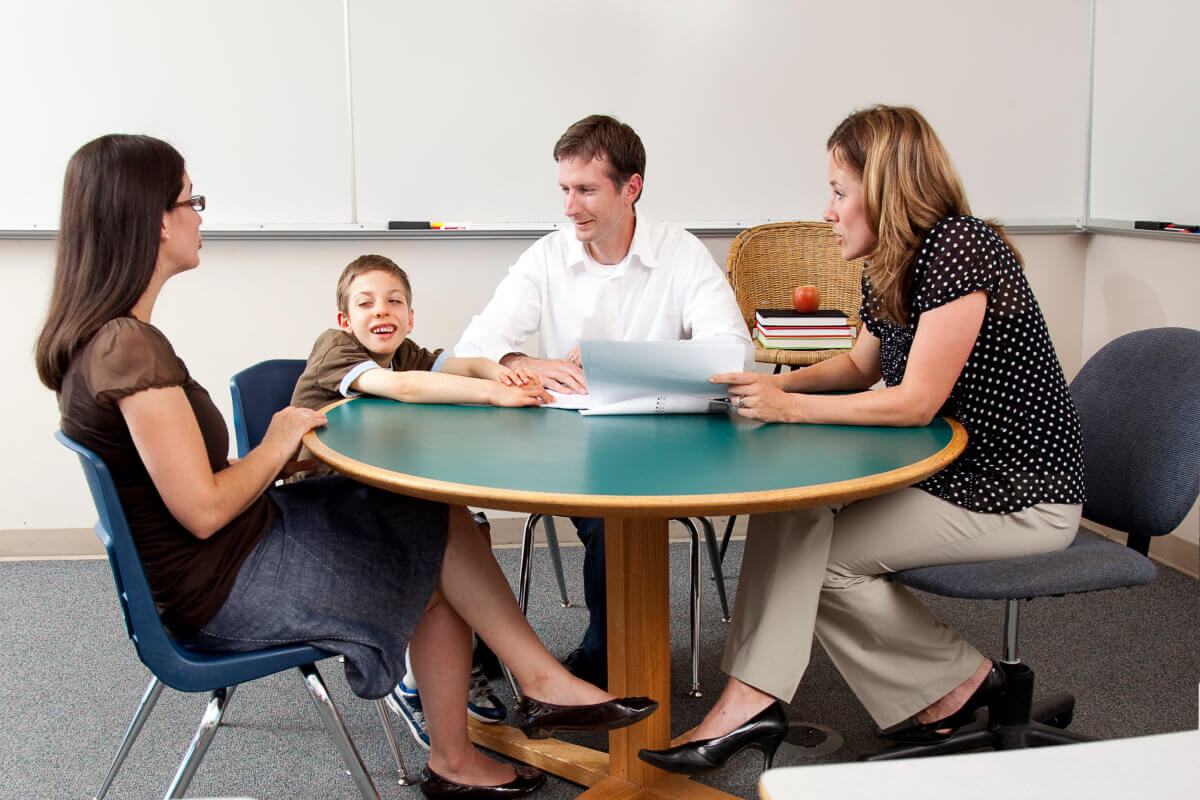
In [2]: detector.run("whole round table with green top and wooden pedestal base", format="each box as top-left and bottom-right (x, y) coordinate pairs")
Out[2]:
(304, 397), (966, 798)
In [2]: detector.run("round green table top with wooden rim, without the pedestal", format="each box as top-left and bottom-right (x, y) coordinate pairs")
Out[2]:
(305, 397), (965, 513)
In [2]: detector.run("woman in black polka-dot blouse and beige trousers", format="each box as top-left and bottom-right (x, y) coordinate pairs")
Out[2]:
(641, 106), (1084, 772)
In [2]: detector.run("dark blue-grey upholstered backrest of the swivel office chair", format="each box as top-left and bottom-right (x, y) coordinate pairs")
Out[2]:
(1070, 327), (1200, 553)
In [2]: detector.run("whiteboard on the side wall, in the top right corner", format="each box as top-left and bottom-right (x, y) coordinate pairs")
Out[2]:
(1091, 0), (1200, 224)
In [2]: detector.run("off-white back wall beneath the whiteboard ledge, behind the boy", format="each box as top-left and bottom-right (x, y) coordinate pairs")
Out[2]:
(0, 235), (1086, 530)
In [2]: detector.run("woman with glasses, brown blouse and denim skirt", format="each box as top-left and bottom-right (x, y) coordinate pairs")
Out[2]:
(36, 136), (656, 798)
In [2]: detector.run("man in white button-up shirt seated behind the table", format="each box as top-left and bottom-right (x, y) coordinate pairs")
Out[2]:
(455, 115), (754, 686)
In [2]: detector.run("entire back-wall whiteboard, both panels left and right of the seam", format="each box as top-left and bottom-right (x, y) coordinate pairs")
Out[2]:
(0, 0), (1094, 231)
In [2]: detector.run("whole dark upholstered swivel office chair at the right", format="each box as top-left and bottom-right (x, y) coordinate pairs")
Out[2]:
(863, 327), (1200, 760)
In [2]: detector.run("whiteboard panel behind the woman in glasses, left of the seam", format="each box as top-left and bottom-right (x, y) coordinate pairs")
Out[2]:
(0, 0), (353, 229)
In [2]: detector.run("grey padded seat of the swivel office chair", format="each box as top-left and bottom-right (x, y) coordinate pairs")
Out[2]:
(892, 536), (1158, 600)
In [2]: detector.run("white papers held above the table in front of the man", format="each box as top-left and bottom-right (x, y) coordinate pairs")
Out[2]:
(544, 339), (744, 415)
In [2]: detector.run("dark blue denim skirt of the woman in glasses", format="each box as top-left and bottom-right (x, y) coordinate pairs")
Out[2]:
(184, 475), (448, 698)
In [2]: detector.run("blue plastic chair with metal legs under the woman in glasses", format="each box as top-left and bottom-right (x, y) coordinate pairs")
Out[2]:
(54, 431), (379, 800)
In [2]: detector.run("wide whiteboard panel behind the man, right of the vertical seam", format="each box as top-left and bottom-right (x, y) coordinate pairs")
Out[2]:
(349, 0), (1090, 225)
